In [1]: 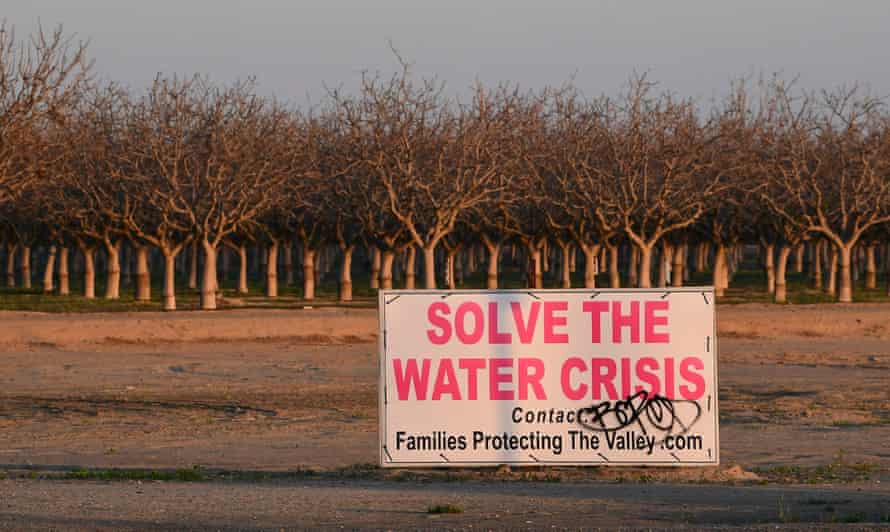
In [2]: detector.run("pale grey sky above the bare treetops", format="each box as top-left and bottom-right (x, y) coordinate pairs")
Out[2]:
(6, 0), (890, 103)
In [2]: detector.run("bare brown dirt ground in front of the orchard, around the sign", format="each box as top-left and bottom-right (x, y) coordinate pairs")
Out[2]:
(0, 304), (890, 530)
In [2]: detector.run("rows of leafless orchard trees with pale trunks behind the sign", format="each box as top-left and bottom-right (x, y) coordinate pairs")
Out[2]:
(0, 26), (890, 309)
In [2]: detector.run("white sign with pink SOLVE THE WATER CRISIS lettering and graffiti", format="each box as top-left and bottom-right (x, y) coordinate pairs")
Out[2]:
(379, 287), (719, 467)
